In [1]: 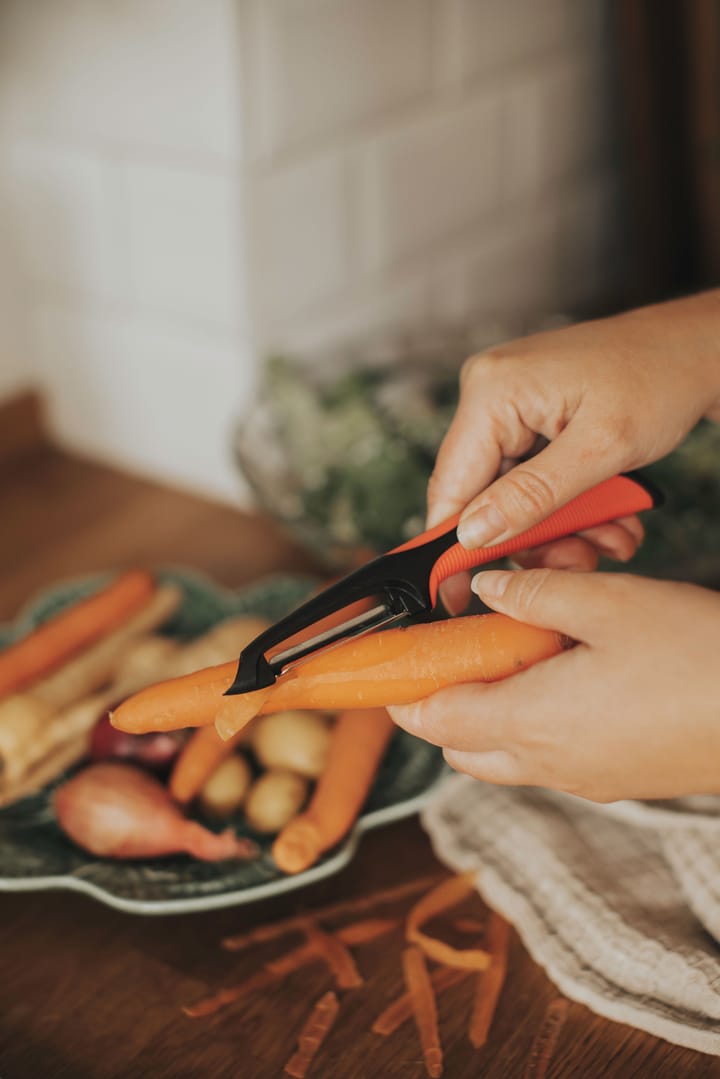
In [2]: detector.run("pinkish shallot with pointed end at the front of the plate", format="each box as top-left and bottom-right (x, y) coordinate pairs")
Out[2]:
(54, 763), (257, 862)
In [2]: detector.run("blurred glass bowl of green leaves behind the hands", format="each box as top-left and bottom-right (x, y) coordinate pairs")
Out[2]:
(234, 329), (720, 587)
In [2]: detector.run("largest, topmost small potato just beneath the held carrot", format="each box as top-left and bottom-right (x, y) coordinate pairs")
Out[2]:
(250, 712), (330, 779)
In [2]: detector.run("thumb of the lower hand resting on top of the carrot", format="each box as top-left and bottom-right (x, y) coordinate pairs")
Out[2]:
(473, 570), (622, 643)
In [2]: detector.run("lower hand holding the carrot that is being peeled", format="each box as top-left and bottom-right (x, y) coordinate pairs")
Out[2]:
(389, 569), (720, 802)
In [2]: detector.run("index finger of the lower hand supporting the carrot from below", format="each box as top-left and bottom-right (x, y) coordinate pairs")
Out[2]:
(388, 686), (507, 751)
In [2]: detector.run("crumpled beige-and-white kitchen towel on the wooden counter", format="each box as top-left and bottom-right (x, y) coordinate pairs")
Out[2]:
(422, 776), (720, 1055)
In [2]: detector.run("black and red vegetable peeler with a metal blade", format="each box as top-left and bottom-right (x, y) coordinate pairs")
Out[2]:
(227, 473), (663, 696)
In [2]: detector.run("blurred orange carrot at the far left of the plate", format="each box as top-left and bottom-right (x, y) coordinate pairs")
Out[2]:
(0, 570), (154, 696)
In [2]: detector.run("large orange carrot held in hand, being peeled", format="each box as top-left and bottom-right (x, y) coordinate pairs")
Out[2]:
(112, 614), (566, 738)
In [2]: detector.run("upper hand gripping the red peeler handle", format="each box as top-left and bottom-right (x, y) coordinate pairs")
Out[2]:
(427, 291), (720, 610)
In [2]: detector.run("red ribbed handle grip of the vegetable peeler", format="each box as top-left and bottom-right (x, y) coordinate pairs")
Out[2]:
(430, 476), (655, 605)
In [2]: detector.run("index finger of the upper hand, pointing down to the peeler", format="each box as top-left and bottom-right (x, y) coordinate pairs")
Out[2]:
(427, 394), (502, 529)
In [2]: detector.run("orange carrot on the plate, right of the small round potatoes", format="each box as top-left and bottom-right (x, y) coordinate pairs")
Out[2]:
(272, 708), (393, 873)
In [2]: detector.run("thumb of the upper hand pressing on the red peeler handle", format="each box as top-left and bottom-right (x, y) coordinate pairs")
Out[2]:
(458, 423), (615, 550)
